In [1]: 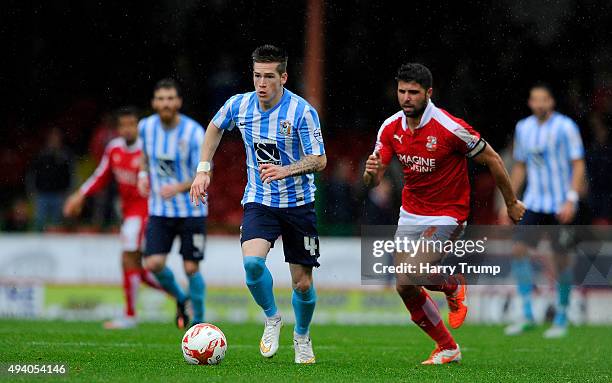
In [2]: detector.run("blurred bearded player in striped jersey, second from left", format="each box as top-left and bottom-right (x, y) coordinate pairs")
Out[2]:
(138, 79), (208, 328)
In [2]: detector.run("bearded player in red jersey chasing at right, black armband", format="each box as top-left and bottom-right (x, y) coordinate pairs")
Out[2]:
(363, 63), (525, 364)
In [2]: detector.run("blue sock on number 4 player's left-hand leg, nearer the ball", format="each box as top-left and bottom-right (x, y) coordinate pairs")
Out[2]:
(242, 257), (278, 317)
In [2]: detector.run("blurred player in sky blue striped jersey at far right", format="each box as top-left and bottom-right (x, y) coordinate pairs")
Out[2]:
(506, 84), (585, 338)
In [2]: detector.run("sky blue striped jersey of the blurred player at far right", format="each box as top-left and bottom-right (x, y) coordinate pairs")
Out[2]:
(514, 112), (584, 214)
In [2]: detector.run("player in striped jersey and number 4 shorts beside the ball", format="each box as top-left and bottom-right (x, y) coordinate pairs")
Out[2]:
(191, 45), (327, 363)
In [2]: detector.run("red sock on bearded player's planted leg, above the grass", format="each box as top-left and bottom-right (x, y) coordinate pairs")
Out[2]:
(404, 288), (457, 350)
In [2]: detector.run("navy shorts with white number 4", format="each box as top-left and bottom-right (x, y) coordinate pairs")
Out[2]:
(240, 202), (320, 267)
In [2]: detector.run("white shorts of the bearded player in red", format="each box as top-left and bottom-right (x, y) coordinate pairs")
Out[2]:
(395, 208), (465, 241)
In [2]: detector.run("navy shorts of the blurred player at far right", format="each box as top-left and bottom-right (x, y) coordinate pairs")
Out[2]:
(512, 210), (571, 252)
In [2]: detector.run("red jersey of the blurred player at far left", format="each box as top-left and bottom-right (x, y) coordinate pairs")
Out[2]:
(81, 137), (148, 218)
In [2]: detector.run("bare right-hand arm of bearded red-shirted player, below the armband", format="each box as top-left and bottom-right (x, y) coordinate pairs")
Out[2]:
(472, 141), (525, 223)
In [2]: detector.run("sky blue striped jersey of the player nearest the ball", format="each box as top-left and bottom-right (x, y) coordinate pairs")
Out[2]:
(212, 89), (325, 207)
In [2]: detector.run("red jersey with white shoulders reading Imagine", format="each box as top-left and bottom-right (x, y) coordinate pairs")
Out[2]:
(375, 101), (486, 222)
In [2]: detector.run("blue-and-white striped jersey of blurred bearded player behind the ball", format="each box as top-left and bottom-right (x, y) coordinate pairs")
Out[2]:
(138, 114), (208, 218)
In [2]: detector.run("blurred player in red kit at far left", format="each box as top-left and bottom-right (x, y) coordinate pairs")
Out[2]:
(64, 108), (161, 329)
